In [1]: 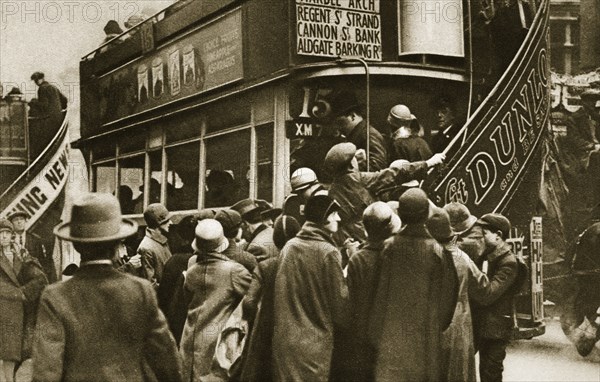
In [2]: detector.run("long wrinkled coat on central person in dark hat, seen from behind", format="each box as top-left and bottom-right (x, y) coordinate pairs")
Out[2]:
(273, 222), (348, 382)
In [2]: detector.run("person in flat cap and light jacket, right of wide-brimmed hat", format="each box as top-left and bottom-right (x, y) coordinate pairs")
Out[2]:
(137, 203), (173, 288)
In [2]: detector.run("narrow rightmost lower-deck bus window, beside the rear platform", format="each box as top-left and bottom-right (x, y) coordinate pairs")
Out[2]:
(256, 123), (276, 200)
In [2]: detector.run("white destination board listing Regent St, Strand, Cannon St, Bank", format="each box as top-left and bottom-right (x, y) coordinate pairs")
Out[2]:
(296, 0), (381, 61)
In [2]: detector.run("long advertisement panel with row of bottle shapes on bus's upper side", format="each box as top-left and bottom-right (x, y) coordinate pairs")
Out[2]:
(95, 10), (244, 123)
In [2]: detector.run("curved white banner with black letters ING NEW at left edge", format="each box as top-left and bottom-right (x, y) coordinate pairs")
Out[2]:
(0, 134), (69, 228)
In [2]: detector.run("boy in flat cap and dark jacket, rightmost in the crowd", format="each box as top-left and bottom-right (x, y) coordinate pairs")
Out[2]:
(473, 213), (519, 382)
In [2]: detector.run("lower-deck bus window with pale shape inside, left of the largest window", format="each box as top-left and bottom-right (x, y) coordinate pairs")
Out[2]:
(167, 142), (200, 211)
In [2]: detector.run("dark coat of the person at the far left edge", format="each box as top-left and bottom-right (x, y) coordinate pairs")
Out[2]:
(0, 247), (48, 361)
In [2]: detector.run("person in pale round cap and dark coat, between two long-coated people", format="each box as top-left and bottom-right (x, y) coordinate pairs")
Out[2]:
(339, 202), (401, 381)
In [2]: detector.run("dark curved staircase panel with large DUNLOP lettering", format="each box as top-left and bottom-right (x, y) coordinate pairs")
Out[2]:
(426, 2), (550, 216)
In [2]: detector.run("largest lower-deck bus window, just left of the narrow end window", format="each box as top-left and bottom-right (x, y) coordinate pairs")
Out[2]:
(204, 129), (250, 208)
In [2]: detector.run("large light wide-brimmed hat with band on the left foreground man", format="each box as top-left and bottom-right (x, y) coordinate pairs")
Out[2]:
(54, 193), (137, 243)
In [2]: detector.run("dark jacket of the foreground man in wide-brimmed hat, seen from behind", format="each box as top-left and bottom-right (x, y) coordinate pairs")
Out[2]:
(33, 264), (181, 382)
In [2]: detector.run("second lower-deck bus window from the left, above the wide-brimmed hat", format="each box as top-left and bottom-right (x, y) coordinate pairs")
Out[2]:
(119, 155), (145, 214)
